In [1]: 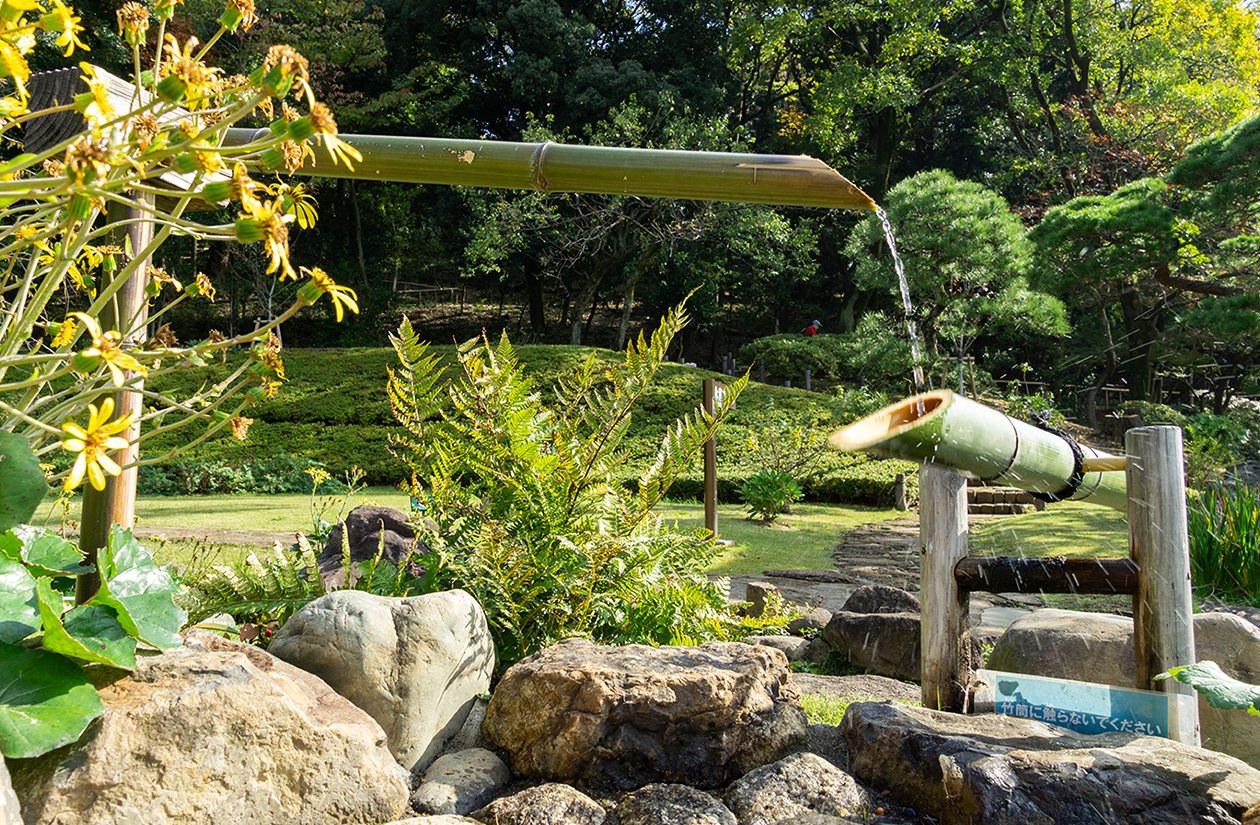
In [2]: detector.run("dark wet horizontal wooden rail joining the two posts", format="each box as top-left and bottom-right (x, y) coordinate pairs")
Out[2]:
(954, 555), (1138, 596)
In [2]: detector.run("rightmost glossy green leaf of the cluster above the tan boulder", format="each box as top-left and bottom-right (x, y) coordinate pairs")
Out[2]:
(89, 525), (188, 649)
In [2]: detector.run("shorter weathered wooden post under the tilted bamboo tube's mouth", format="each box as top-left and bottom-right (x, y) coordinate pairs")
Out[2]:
(919, 464), (971, 713)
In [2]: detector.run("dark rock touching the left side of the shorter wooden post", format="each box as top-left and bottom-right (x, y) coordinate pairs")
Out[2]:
(823, 609), (922, 681)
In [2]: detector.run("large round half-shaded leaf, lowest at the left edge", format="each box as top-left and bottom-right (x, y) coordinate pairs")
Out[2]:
(0, 642), (105, 760)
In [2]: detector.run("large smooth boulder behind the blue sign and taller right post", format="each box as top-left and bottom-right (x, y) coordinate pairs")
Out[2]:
(989, 610), (1260, 767)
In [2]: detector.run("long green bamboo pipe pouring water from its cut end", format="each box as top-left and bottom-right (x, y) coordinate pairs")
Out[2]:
(223, 128), (876, 209)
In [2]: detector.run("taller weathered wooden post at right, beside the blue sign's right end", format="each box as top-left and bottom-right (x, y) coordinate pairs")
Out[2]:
(1124, 427), (1200, 746)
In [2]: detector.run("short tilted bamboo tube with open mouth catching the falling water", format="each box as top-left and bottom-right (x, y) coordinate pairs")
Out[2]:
(829, 389), (1129, 510)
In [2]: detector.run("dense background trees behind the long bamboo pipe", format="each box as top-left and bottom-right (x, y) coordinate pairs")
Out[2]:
(38, 0), (1260, 408)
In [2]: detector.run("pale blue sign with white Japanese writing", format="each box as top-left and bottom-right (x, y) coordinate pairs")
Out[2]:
(973, 670), (1168, 737)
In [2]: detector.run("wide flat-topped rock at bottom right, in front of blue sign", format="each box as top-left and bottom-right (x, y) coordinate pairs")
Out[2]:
(840, 704), (1260, 825)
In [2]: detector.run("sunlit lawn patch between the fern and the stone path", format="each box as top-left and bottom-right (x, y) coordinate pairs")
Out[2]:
(656, 501), (905, 576)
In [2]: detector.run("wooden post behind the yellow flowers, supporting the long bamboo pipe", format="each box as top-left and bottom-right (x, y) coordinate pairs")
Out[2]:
(74, 194), (154, 605)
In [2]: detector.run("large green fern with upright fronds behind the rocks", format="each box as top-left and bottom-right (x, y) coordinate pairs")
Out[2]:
(389, 298), (747, 668)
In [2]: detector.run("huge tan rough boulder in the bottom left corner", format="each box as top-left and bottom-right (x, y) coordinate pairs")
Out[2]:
(13, 634), (407, 825)
